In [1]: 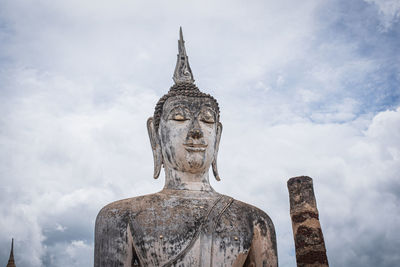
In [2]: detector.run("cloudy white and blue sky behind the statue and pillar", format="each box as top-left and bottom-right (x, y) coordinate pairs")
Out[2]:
(0, 0), (400, 267)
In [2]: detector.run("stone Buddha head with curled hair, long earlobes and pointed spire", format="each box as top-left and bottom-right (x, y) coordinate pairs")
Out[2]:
(147, 30), (222, 184)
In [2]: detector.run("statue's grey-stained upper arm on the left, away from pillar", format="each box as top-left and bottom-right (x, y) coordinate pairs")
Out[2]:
(94, 207), (132, 267)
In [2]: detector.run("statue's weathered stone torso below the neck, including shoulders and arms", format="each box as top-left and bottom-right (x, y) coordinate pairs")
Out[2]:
(95, 193), (276, 266)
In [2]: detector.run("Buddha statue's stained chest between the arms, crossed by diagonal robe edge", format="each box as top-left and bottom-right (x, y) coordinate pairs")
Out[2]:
(130, 198), (253, 266)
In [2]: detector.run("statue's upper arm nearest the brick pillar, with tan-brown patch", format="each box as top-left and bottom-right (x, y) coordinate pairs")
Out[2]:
(244, 214), (278, 267)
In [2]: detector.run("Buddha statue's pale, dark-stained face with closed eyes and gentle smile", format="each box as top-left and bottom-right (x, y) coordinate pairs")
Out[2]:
(158, 96), (219, 173)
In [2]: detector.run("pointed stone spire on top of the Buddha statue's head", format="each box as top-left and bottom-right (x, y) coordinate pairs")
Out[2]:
(173, 27), (194, 83)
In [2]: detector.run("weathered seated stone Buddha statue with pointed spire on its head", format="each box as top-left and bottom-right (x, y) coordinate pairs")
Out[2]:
(94, 29), (278, 267)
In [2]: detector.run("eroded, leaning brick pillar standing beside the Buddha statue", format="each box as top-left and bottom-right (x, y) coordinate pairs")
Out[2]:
(287, 176), (329, 267)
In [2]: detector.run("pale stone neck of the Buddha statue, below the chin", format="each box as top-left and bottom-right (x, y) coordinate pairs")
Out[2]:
(163, 166), (214, 192)
